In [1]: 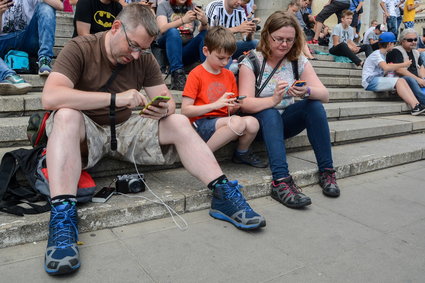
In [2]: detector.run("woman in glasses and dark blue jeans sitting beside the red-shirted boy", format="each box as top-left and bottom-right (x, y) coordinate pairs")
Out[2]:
(239, 12), (340, 208)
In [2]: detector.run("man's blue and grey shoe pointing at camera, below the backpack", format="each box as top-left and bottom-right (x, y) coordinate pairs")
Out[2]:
(44, 202), (80, 275)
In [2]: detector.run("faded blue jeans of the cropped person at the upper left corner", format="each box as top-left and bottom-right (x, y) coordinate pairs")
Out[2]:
(0, 2), (56, 80)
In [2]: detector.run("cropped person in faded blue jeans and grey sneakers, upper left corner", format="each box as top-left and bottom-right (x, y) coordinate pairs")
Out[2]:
(0, 0), (63, 94)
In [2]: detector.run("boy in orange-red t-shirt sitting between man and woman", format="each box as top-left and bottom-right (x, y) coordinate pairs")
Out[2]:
(182, 26), (267, 168)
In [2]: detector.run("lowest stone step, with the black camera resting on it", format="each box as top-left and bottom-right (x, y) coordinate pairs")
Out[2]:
(0, 134), (425, 248)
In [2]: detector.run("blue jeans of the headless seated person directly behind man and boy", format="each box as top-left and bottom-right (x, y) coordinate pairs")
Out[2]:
(158, 28), (207, 72)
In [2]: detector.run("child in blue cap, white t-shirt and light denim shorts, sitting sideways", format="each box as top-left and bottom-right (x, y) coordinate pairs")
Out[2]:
(362, 32), (425, 116)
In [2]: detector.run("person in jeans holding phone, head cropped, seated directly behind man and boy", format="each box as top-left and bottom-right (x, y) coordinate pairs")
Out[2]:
(156, 0), (208, 90)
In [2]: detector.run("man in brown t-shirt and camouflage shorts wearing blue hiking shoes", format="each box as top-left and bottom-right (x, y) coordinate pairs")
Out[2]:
(42, 3), (266, 275)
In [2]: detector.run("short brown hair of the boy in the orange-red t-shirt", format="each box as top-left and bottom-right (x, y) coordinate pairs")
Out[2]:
(204, 26), (236, 54)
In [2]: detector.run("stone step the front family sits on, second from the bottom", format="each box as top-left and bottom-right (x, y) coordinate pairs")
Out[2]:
(0, 110), (425, 154)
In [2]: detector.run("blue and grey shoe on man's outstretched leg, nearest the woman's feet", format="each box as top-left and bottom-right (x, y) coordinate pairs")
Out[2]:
(210, 181), (266, 230)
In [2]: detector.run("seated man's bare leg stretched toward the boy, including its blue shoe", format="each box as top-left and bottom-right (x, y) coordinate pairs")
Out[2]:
(159, 114), (266, 230)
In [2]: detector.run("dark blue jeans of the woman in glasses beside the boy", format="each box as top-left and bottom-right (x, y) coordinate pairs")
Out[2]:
(254, 99), (333, 180)
